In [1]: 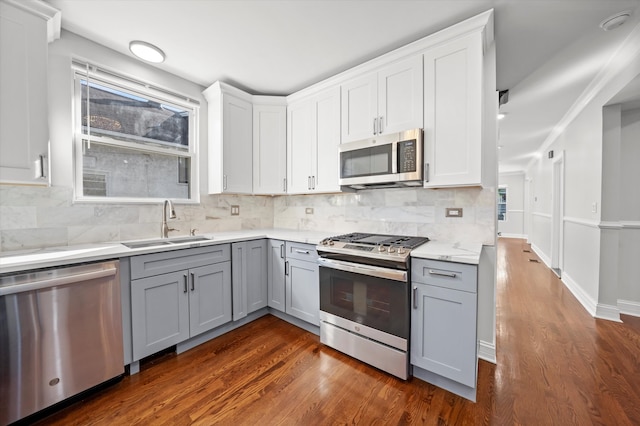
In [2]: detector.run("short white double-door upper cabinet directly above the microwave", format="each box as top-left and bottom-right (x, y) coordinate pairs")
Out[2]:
(342, 55), (423, 143)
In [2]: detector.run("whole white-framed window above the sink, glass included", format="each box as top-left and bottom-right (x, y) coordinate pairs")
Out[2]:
(74, 62), (198, 202)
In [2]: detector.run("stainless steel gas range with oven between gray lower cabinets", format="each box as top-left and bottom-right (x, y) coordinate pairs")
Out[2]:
(316, 233), (429, 379)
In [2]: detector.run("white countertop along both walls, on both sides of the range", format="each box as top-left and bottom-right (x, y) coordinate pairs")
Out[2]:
(0, 229), (482, 274)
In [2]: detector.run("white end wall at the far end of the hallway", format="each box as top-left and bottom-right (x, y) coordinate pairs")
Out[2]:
(498, 172), (527, 238)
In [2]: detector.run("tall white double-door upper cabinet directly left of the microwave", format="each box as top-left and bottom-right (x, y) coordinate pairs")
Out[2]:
(287, 87), (340, 194)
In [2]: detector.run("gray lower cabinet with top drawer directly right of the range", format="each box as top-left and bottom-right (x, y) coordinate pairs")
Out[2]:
(410, 259), (478, 388)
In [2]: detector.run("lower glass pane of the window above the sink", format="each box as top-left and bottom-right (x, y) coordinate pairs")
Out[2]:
(83, 142), (191, 199)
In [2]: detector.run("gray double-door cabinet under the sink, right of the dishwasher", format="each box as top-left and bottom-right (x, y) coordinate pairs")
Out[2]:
(131, 244), (231, 361)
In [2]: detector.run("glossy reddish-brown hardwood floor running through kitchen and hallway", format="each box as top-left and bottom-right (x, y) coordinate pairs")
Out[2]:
(33, 239), (640, 425)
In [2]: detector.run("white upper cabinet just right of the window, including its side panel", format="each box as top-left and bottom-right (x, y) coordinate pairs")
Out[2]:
(204, 82), (253, 194)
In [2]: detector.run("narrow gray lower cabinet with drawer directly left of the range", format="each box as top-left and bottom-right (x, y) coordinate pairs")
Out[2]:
(285, 242), (320, 325)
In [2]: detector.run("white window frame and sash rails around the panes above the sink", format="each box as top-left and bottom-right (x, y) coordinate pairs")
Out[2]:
(71, 60), (200, 204)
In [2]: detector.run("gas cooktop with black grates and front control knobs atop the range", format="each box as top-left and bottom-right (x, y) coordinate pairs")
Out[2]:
(316, 233), (429, 263)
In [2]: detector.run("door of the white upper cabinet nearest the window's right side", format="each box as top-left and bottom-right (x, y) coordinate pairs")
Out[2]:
(222, 94), (253, 194)
